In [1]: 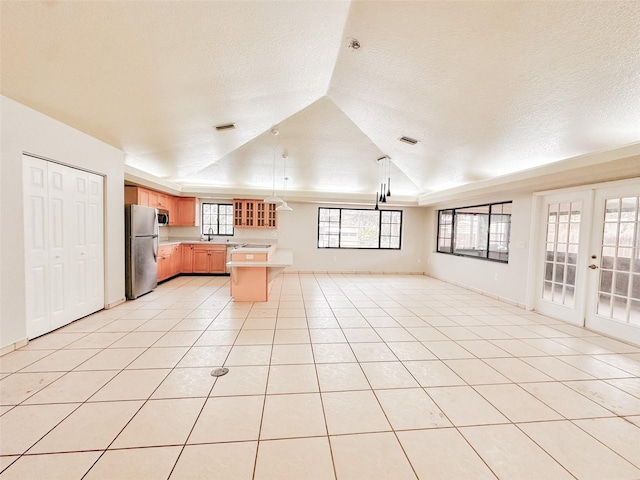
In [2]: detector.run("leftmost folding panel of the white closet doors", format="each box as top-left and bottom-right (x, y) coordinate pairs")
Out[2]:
(22, 155), (51, 338)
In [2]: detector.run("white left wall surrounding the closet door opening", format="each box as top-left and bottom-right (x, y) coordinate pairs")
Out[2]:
(0, 96), (124, 350)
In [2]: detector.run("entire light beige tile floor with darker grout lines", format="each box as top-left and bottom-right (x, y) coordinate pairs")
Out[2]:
(0, 274), (640, 480)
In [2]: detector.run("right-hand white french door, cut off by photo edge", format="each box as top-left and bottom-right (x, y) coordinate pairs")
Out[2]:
(585, 182), (640, 345)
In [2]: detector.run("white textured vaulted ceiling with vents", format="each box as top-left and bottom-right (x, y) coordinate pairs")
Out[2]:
(0, 0), (640, 201)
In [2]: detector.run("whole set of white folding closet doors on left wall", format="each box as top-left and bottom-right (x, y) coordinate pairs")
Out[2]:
(23, 155), (104, 338)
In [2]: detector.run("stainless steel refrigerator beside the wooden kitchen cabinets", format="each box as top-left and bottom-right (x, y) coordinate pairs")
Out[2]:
(124, 205), (159, 300)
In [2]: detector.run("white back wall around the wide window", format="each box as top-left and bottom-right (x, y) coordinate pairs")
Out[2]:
(278, 202), (426, 273)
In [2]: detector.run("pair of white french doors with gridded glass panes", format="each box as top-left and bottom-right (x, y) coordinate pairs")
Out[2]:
(534, 180), (640, 345)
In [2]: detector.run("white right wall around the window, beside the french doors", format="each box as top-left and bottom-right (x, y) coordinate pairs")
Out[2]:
(425, 193), (533, 305)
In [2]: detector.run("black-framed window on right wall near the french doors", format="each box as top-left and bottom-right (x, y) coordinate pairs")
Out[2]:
(437, 202), (511, 263)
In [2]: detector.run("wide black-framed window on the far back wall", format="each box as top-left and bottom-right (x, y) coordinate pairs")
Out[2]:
(318, 207), (402, 250)
